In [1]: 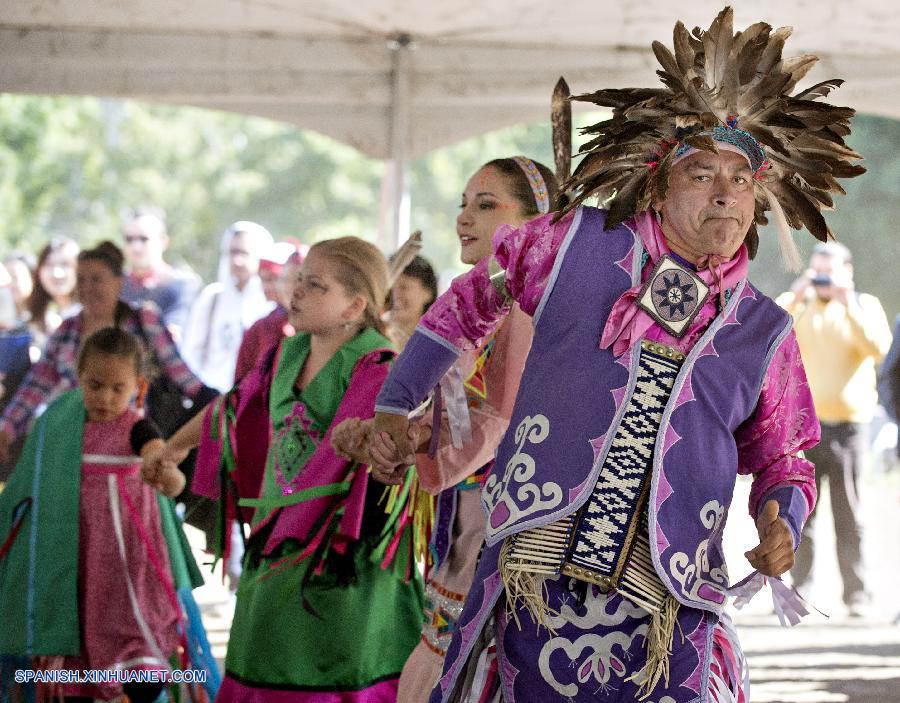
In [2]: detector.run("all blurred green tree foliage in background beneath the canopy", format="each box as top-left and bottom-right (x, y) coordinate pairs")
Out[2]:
(0, 95), (900, 314)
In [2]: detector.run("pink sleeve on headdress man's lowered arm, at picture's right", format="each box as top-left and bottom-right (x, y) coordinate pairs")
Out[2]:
(735, 330), (819, 533)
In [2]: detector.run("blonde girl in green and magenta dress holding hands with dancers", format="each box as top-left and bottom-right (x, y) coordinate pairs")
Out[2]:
(144, 237), (422, 703)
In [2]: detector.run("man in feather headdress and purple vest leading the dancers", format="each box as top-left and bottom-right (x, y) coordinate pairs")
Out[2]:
(371, 8), (863, 703)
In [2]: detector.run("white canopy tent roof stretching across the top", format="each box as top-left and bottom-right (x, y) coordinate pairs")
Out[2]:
(0, 0), (900, 246)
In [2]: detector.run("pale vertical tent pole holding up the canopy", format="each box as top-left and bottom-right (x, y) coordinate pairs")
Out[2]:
(385, 34), (411, 251)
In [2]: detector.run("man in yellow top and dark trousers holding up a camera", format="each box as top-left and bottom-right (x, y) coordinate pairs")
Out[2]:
(777, 242), (891, 616)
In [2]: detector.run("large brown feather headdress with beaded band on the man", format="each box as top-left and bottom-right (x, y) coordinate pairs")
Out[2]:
(560, 7), (865, 265)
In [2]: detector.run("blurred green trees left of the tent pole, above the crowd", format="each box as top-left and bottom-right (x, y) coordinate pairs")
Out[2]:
(0, 95), (382, 278)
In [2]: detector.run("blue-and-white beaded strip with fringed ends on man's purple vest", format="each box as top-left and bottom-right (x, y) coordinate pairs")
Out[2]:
(500, 340), (684, 694)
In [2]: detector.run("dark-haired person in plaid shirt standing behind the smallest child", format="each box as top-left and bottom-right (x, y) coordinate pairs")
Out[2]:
(0, 242), (208, 462)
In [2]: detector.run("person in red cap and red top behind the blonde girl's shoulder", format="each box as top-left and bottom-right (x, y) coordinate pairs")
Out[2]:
(234, 242), (309, 384)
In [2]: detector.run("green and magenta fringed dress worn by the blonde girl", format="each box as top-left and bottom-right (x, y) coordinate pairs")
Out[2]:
(195, 330), (422, 703)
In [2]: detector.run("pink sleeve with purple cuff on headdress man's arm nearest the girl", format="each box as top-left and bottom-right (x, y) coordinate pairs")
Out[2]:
(376, 213), (574, 415)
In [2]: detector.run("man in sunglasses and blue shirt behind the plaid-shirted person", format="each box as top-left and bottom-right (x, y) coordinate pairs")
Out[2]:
(122, 207), (200, 339)
